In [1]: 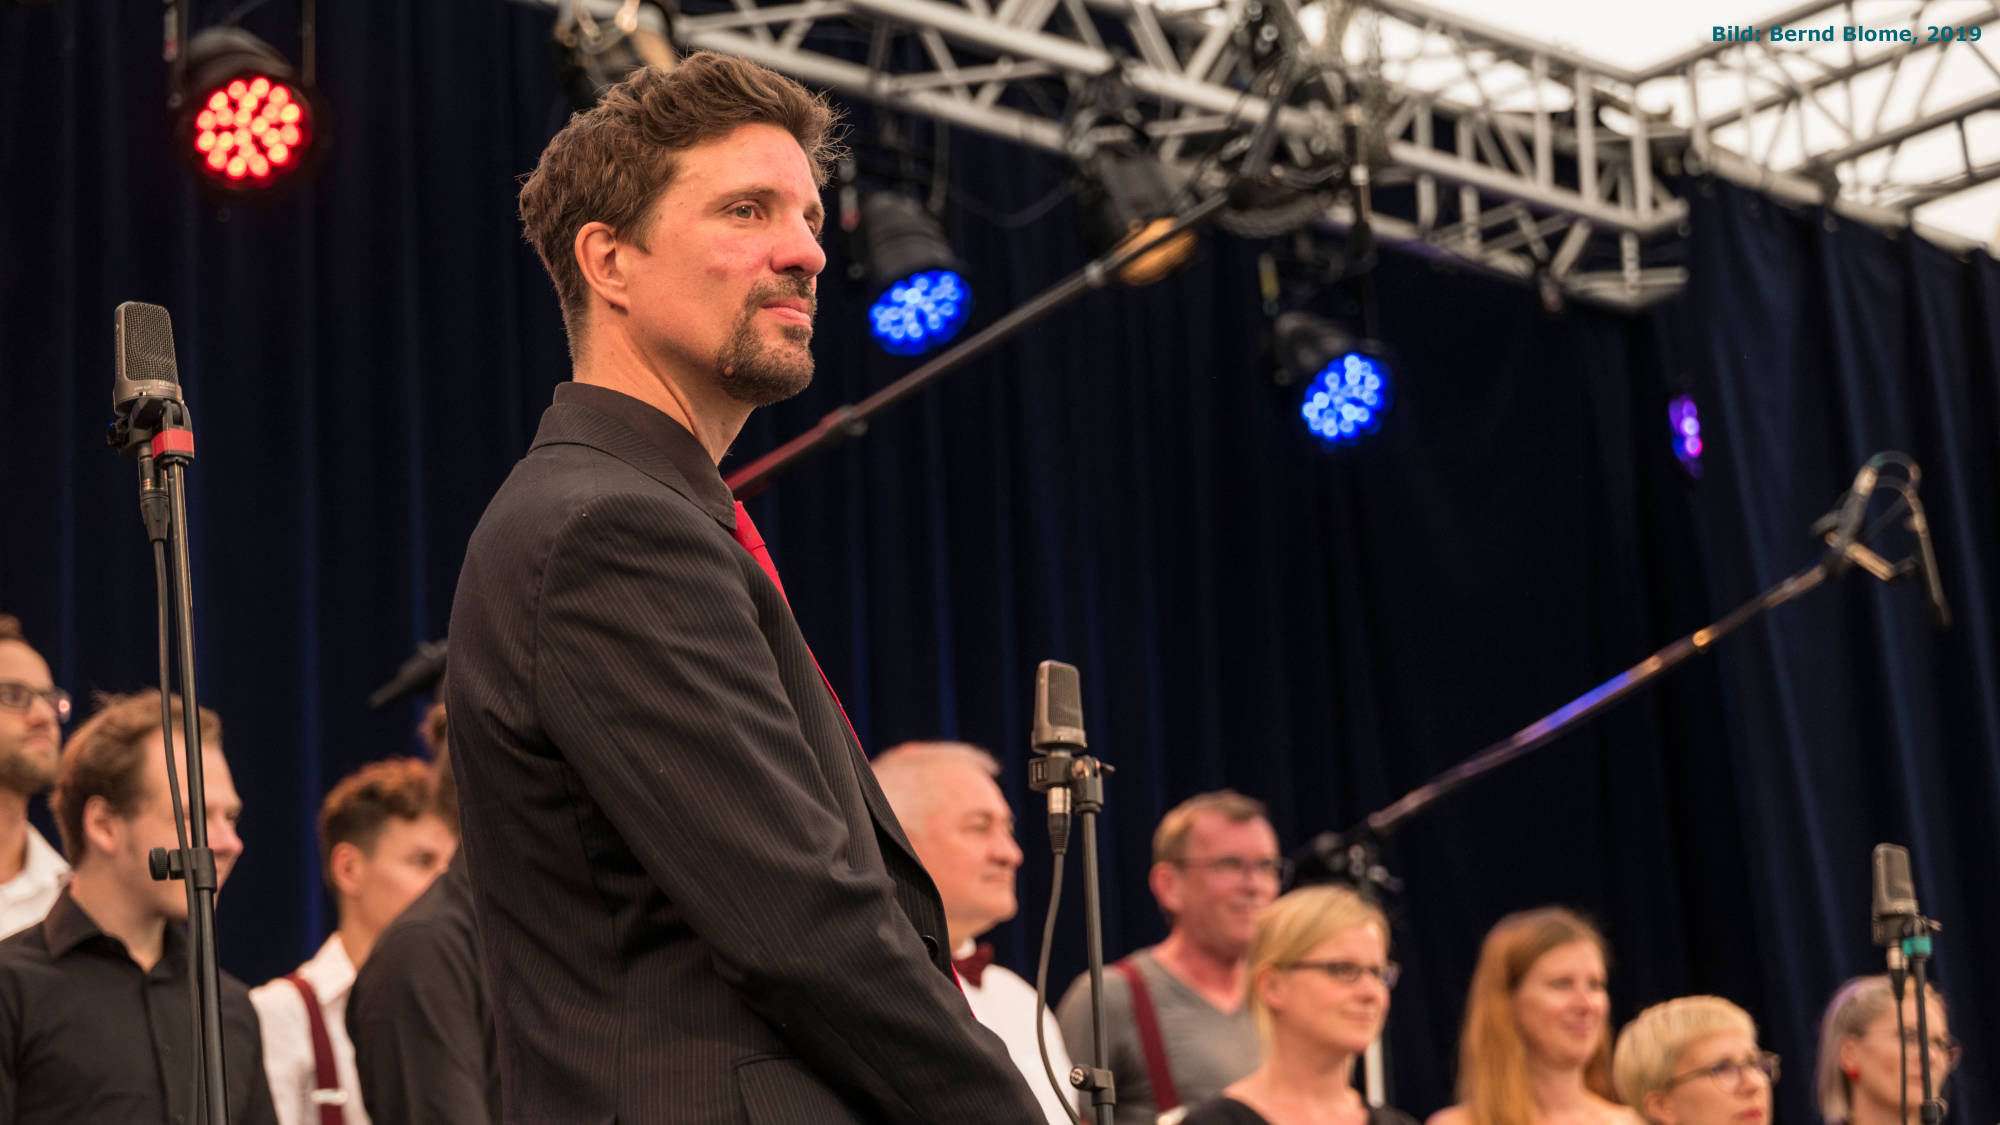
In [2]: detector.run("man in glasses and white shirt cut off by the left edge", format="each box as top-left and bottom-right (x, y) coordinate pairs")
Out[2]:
(0, 613), (70, 937)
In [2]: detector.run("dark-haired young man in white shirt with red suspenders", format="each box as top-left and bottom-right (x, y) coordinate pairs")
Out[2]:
(250, 759), (458, 1125)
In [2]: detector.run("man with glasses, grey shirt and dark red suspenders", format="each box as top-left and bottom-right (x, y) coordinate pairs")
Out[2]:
(1056, 789), (1284, 1125)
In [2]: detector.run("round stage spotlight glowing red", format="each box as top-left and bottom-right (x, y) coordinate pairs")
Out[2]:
(168, 13), (328, 200)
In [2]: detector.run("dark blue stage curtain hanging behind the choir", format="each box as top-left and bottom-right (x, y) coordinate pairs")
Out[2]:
(0, 0), (2000, 1123)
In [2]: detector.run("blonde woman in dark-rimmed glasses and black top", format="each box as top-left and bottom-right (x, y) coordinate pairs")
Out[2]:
(1184, 887), (1416, 1125)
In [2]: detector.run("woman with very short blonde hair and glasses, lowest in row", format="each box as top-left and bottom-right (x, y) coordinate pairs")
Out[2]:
(1612, 997), (1778, 1125)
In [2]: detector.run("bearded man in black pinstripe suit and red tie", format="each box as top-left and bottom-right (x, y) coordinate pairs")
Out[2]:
(446, 54), (1040, 1125)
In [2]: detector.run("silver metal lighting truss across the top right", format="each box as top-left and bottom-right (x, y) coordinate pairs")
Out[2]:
(542, 0), (2000, 308)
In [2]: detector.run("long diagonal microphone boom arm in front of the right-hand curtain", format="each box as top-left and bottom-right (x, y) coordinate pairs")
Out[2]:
(1304, 454), (1936, 1096)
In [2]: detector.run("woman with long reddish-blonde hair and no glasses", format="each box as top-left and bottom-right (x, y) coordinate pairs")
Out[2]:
(1428, 907), (1640, 1125)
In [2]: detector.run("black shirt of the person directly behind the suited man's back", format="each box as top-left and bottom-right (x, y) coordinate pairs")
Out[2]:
(348, 849), (500, 1125)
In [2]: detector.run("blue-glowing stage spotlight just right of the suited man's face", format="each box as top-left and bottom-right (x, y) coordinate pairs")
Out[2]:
(856, 188), (972, 356)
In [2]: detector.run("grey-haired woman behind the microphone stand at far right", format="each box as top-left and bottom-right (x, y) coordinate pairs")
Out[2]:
(1812, 975), (1958, 1125)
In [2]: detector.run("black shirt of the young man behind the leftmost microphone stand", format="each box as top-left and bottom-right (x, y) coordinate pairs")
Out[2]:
(0, 889), (278, 1125)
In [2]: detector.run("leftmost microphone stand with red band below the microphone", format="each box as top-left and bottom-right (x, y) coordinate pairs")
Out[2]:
(108, 398), (228, 1125)
